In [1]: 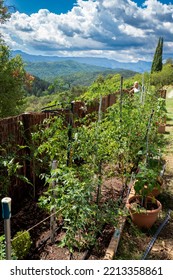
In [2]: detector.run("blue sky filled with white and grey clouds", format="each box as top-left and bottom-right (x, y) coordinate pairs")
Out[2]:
(0, 0), (173, 62)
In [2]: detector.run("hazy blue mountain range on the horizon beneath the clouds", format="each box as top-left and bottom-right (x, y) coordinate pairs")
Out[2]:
(12, 51), (151, 73)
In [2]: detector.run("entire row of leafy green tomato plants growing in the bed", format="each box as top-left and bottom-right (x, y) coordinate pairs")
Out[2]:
(32, 79), (164, 251)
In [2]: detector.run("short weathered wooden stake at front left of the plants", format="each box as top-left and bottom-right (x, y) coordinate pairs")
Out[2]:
(50, 160), (57, 244)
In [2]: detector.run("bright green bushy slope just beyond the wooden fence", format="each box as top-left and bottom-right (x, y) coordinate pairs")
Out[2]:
(23, 62), (173, 111)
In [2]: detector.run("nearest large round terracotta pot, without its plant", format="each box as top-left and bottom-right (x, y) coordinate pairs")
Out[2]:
(126, 195), (162, 229)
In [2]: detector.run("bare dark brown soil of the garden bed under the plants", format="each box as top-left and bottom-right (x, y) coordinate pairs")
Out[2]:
(0, 173), (128, 260)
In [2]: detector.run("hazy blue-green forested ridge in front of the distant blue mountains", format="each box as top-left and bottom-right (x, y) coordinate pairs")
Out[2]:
(25, 60), (136, 83)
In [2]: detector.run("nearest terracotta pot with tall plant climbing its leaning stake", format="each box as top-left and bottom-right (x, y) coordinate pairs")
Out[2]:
(127, 97), (162, 228)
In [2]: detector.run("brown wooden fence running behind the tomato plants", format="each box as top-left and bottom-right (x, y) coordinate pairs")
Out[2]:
(0, 93), (116, 204)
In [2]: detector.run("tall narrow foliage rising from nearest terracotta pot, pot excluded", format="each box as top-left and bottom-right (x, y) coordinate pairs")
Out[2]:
(134, 95), (165, 207)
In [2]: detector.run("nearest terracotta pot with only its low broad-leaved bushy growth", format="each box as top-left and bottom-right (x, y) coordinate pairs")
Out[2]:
(127, 160), (162, 228)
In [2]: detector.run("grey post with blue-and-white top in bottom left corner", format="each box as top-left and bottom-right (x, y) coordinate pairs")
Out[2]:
(1, 197), (11, 260)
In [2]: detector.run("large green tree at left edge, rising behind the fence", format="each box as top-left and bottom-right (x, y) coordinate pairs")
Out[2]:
(0, 44), (28, 118)
